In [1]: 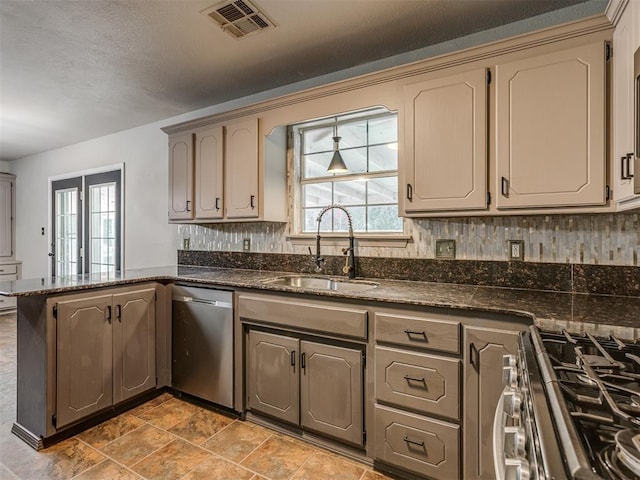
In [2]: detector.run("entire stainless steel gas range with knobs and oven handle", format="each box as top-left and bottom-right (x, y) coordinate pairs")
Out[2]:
(494, 327), (640, 480)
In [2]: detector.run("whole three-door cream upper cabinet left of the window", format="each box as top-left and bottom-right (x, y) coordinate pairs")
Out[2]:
(169, 118), (287, 222)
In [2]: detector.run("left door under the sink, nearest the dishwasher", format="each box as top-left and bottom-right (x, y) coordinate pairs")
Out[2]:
(248, 330), (300, 425)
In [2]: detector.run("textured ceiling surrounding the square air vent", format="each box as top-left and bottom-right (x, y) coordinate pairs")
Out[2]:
(0, 0), (596, 160)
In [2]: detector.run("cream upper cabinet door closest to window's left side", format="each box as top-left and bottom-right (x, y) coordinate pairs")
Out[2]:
(225, 118), (259, 218)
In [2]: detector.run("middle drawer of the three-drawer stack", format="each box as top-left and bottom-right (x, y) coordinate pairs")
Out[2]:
(375, 347), (460, 420)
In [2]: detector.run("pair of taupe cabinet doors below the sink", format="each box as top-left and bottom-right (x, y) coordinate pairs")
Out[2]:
(248, 330), (364, 446)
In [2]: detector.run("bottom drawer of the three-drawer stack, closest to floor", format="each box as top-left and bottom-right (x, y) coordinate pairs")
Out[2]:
(375, 405), (460, 480)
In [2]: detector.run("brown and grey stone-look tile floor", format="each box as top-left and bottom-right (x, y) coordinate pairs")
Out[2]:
(0, 315), (388, 480)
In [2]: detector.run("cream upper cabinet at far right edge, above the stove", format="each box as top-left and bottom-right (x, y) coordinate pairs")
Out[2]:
(612, 1), (640, 210)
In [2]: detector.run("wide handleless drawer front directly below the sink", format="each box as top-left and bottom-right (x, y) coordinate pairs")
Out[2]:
(238, 295), (367, 338)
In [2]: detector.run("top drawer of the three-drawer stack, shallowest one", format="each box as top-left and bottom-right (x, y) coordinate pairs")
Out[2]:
(374, 312), (460, 353)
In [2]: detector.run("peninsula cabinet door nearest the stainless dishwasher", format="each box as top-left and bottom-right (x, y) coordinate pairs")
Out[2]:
(113, 288), (156, 403)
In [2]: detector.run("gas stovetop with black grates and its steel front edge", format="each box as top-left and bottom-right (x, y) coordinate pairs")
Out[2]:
(532, 327), (640, 480)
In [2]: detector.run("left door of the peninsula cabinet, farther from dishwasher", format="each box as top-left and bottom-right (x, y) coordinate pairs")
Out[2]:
(56, 295), (113, 429)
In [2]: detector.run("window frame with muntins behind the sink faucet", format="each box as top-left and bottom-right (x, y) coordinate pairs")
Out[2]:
(288, 107), (402, 236)
